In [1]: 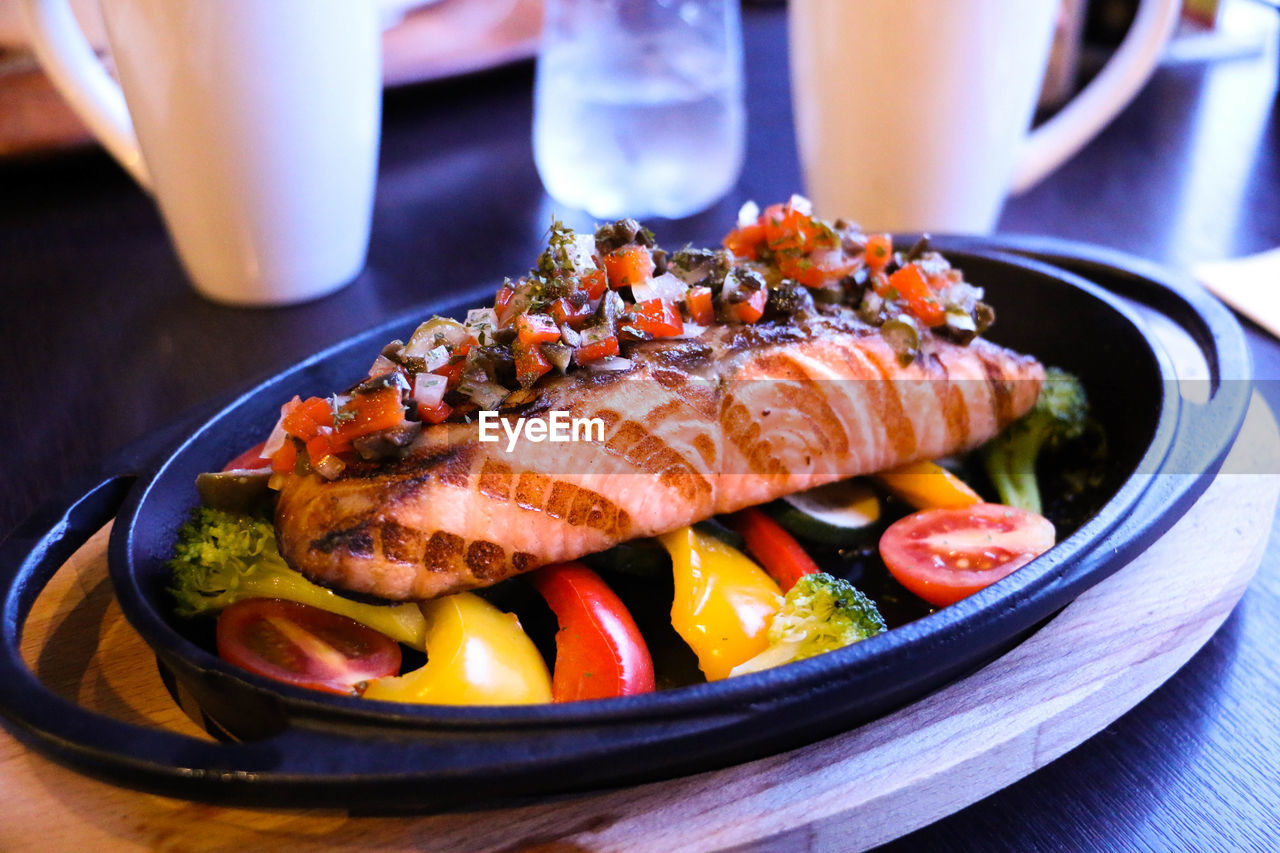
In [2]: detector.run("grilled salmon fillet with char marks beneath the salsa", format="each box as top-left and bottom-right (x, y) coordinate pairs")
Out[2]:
(276, 307), (1044, 599)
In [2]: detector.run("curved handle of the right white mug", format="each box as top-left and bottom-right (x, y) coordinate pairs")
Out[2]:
(1011, 0), (1183, 192)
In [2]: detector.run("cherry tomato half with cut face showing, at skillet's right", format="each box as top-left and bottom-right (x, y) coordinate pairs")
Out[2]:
(879, 503), (1053, 607)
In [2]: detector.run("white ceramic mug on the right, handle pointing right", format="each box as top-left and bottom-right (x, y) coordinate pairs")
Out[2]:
(788, 0), (1180, 233)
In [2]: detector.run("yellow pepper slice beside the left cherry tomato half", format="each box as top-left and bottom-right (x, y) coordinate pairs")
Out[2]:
(364, 593), (552, 704)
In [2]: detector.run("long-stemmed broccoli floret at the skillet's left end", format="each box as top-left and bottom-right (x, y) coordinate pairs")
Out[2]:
(169, 506), (426, 649)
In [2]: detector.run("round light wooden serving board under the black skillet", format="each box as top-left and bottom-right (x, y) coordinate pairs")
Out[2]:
(0, 394), (1280, 853)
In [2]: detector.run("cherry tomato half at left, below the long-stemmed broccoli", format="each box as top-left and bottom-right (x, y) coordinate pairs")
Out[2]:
(218, 598), (401, 694)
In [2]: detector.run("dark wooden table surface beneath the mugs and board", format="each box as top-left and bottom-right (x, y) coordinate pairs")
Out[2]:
(0, 8), (1280, 850)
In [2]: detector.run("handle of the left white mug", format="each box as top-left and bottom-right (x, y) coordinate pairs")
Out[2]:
(22, 0), (151, 185)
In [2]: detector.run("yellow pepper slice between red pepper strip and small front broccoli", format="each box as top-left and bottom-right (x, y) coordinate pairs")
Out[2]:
(659, 528), (782, 681)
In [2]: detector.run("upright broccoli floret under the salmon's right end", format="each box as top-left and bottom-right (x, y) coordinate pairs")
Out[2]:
(982, 368), (1089, 512)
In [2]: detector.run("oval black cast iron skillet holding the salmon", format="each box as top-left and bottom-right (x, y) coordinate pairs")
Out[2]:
(0, 240), (1249, 811)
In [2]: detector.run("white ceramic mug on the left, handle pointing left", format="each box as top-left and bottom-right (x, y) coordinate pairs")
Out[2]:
(23, 0), (383, 305)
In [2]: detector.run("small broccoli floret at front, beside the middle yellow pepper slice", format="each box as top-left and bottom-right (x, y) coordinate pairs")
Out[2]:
(731, 571), (886, 675)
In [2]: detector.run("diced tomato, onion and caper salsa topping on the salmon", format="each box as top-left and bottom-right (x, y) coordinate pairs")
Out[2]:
(262, 196), (995, 479)
